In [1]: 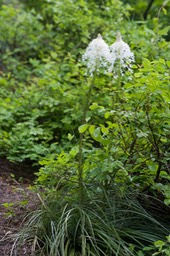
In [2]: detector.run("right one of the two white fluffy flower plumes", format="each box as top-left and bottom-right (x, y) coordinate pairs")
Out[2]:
(110, 33), (134, 73)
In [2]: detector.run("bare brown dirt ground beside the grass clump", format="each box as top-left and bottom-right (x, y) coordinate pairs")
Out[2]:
(0, 158), (38, 256)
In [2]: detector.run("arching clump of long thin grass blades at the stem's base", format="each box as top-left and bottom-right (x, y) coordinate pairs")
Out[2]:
(13, 187), (170, 256)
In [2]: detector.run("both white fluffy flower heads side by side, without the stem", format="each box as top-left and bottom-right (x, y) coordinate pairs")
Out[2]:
(83, 33), (134, 76)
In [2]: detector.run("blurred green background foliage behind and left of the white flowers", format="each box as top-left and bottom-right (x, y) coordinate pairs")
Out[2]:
(0, 0), (169, 164)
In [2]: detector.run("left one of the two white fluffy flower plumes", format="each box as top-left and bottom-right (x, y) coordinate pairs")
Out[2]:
(82, 34), (110, 76)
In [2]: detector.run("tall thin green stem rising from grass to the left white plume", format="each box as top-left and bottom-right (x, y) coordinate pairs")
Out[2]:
(78, 72), (96, 203)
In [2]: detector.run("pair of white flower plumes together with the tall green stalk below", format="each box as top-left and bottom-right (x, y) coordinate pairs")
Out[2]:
(78, 33), (134, 202)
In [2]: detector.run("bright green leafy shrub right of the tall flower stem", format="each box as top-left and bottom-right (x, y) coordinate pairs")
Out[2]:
(35, 59), (170, 193)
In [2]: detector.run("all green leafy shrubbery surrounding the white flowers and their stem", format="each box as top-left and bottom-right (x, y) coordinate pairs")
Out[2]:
(0, 0), (170, 192)
